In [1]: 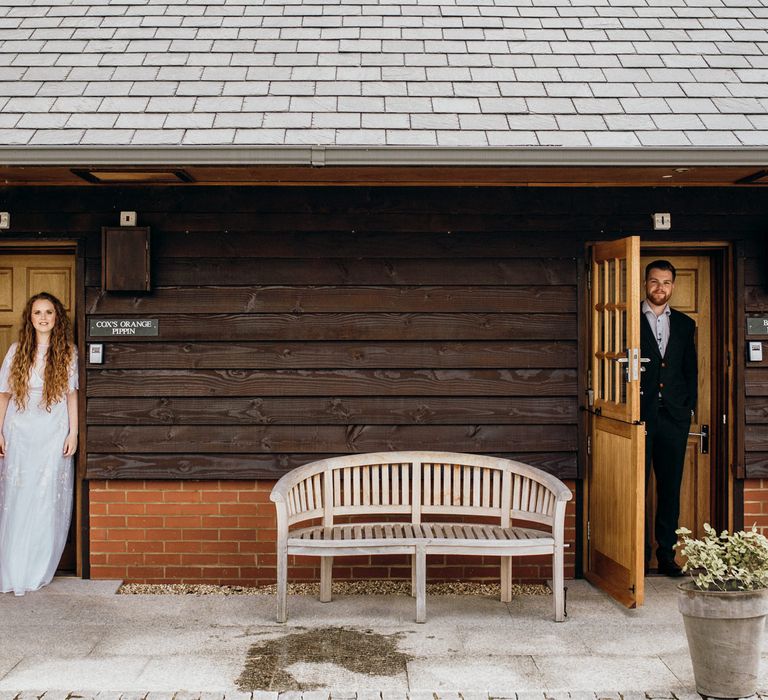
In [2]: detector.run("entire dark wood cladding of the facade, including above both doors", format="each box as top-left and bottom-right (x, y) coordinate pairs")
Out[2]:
(0, 186), (768, 479)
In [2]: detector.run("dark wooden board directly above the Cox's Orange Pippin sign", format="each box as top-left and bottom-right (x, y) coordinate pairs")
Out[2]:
(86, 285), (576, 314)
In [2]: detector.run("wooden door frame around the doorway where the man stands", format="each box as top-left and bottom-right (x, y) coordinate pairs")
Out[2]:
(576, 237), (744, 576)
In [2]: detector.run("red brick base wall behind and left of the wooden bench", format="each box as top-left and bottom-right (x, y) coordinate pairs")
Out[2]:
(90, 480), (576, 586)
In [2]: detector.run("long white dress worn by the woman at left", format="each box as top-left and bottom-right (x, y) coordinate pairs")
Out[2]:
(0, 343), (77, 595)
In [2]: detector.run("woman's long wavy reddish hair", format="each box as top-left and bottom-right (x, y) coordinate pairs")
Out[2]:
(10, 292), (73, 411)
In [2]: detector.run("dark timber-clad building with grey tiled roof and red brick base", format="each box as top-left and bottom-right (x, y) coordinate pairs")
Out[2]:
(0, 0), (768, 604)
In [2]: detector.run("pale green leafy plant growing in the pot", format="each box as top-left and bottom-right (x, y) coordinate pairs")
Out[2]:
(676, 523), (768, 591)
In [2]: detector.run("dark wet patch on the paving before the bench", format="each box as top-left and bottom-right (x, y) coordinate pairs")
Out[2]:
(237, 627), (411, 691)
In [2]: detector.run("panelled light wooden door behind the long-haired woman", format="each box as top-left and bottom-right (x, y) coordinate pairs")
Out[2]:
(0, 252), (77, 573)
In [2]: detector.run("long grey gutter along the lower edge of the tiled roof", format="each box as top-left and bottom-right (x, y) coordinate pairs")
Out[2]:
(0, 146), (768, 167)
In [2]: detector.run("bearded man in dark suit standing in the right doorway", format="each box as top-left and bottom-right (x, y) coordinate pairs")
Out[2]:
(640, 260), (698, 576)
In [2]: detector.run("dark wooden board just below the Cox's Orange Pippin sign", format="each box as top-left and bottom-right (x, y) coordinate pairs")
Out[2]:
(93, 338), (576, 369)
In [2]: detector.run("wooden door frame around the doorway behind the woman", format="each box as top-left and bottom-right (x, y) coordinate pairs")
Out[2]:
(0, 234), (90, 578)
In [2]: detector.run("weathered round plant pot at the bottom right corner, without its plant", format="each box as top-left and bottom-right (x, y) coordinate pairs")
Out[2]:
(677, 581), (768, 698)
